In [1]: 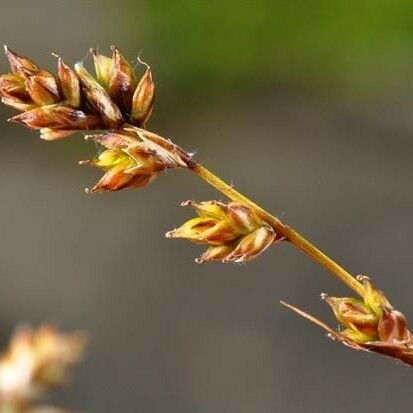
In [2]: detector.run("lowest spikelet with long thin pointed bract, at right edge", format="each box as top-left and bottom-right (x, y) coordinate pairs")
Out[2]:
(282, 276), (413, 366)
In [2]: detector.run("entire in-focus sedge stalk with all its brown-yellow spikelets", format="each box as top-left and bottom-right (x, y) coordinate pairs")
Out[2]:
(0, 47), (413, 366)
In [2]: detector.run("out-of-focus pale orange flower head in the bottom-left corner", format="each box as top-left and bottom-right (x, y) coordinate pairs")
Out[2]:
(0, 325), (87, 413)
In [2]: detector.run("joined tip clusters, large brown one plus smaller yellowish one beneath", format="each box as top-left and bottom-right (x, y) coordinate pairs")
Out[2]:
(0, 46), (189, 192)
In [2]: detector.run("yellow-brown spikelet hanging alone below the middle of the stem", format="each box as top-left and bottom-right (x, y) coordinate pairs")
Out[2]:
(166, 201), (276, 263)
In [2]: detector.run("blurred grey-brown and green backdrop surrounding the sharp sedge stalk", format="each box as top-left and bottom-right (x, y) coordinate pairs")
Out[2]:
(0, 0), (413, 413)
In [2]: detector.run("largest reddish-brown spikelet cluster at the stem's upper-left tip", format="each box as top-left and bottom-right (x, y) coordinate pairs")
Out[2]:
(0, 46), (155, 140)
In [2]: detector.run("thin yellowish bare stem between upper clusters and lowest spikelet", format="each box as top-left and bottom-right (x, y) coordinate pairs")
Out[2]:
(190, 162), (364, 297)
